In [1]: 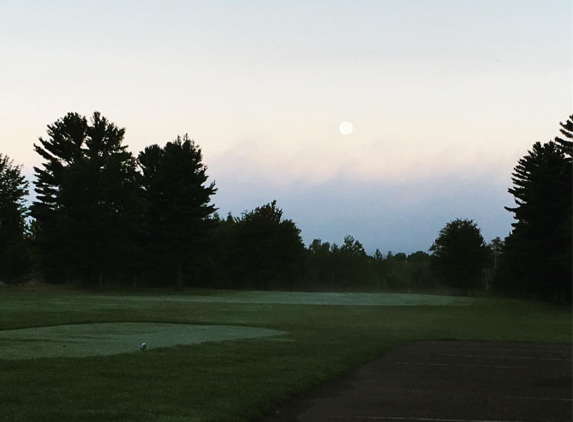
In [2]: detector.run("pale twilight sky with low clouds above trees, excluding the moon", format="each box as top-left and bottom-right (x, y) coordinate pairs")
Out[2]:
(0, 0), (573, 253)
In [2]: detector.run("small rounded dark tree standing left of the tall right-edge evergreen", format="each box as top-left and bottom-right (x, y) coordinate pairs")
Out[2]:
(430, 219), (489, 292)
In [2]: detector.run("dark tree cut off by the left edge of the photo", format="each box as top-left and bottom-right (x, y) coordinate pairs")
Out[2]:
(0, 154), (30, 283)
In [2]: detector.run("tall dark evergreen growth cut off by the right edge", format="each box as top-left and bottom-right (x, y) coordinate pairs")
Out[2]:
(498, 116), (573, 302)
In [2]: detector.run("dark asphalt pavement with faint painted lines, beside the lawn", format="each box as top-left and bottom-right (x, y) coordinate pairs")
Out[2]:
(268, 341), (573, 422)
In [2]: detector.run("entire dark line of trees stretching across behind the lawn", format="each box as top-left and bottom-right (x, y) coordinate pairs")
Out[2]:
(0, 112), (573, 302)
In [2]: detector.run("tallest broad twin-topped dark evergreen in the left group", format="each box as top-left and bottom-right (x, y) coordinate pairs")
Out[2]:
(32, 112), (139, 285)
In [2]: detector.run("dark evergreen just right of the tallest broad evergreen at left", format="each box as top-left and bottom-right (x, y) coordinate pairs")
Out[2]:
(138, 135), (216, 288)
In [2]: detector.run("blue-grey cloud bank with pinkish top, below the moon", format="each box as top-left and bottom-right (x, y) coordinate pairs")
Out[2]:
(209, 149), (513, 253)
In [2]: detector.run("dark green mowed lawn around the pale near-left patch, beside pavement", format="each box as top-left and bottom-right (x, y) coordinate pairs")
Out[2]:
(0, 289), (572, 422)
